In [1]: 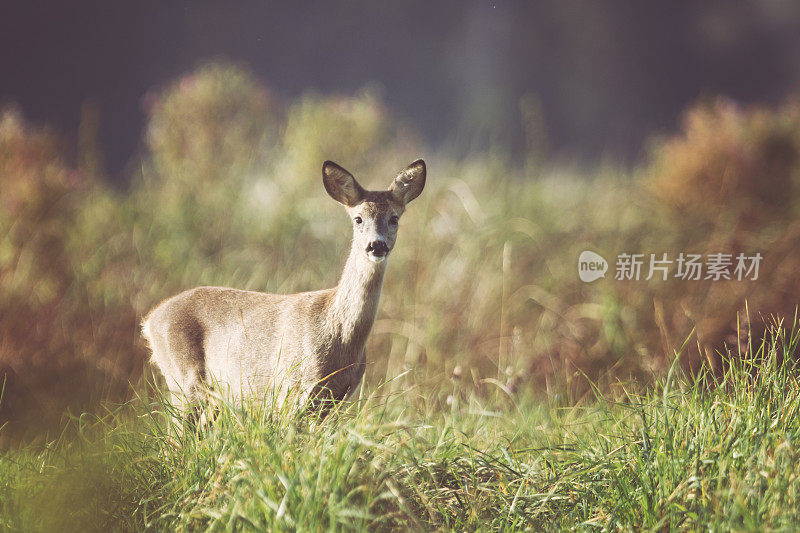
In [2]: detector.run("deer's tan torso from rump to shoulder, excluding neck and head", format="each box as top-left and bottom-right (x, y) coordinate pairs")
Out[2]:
(143, 287), (333, 396)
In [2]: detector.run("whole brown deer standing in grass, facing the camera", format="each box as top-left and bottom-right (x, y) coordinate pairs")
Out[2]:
(142, 159), (426, 414)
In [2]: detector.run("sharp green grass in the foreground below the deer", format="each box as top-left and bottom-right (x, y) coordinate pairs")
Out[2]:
(0, 318), (800, 531)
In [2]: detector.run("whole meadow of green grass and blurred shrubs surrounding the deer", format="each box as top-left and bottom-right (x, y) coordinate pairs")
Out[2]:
(0, 63), (800, 531)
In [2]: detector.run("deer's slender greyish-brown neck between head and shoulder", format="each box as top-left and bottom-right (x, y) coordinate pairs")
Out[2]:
(328, 242), (386, 345)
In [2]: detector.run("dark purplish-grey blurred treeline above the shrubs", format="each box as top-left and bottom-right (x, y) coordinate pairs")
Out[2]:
(0, 0), (800, 180)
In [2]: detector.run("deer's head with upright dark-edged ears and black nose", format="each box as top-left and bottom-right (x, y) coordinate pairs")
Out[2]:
(322, 159), (425, 263)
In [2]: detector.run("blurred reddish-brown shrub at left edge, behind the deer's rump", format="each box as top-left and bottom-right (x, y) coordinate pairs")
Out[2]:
(0, 109), (140, 436)
